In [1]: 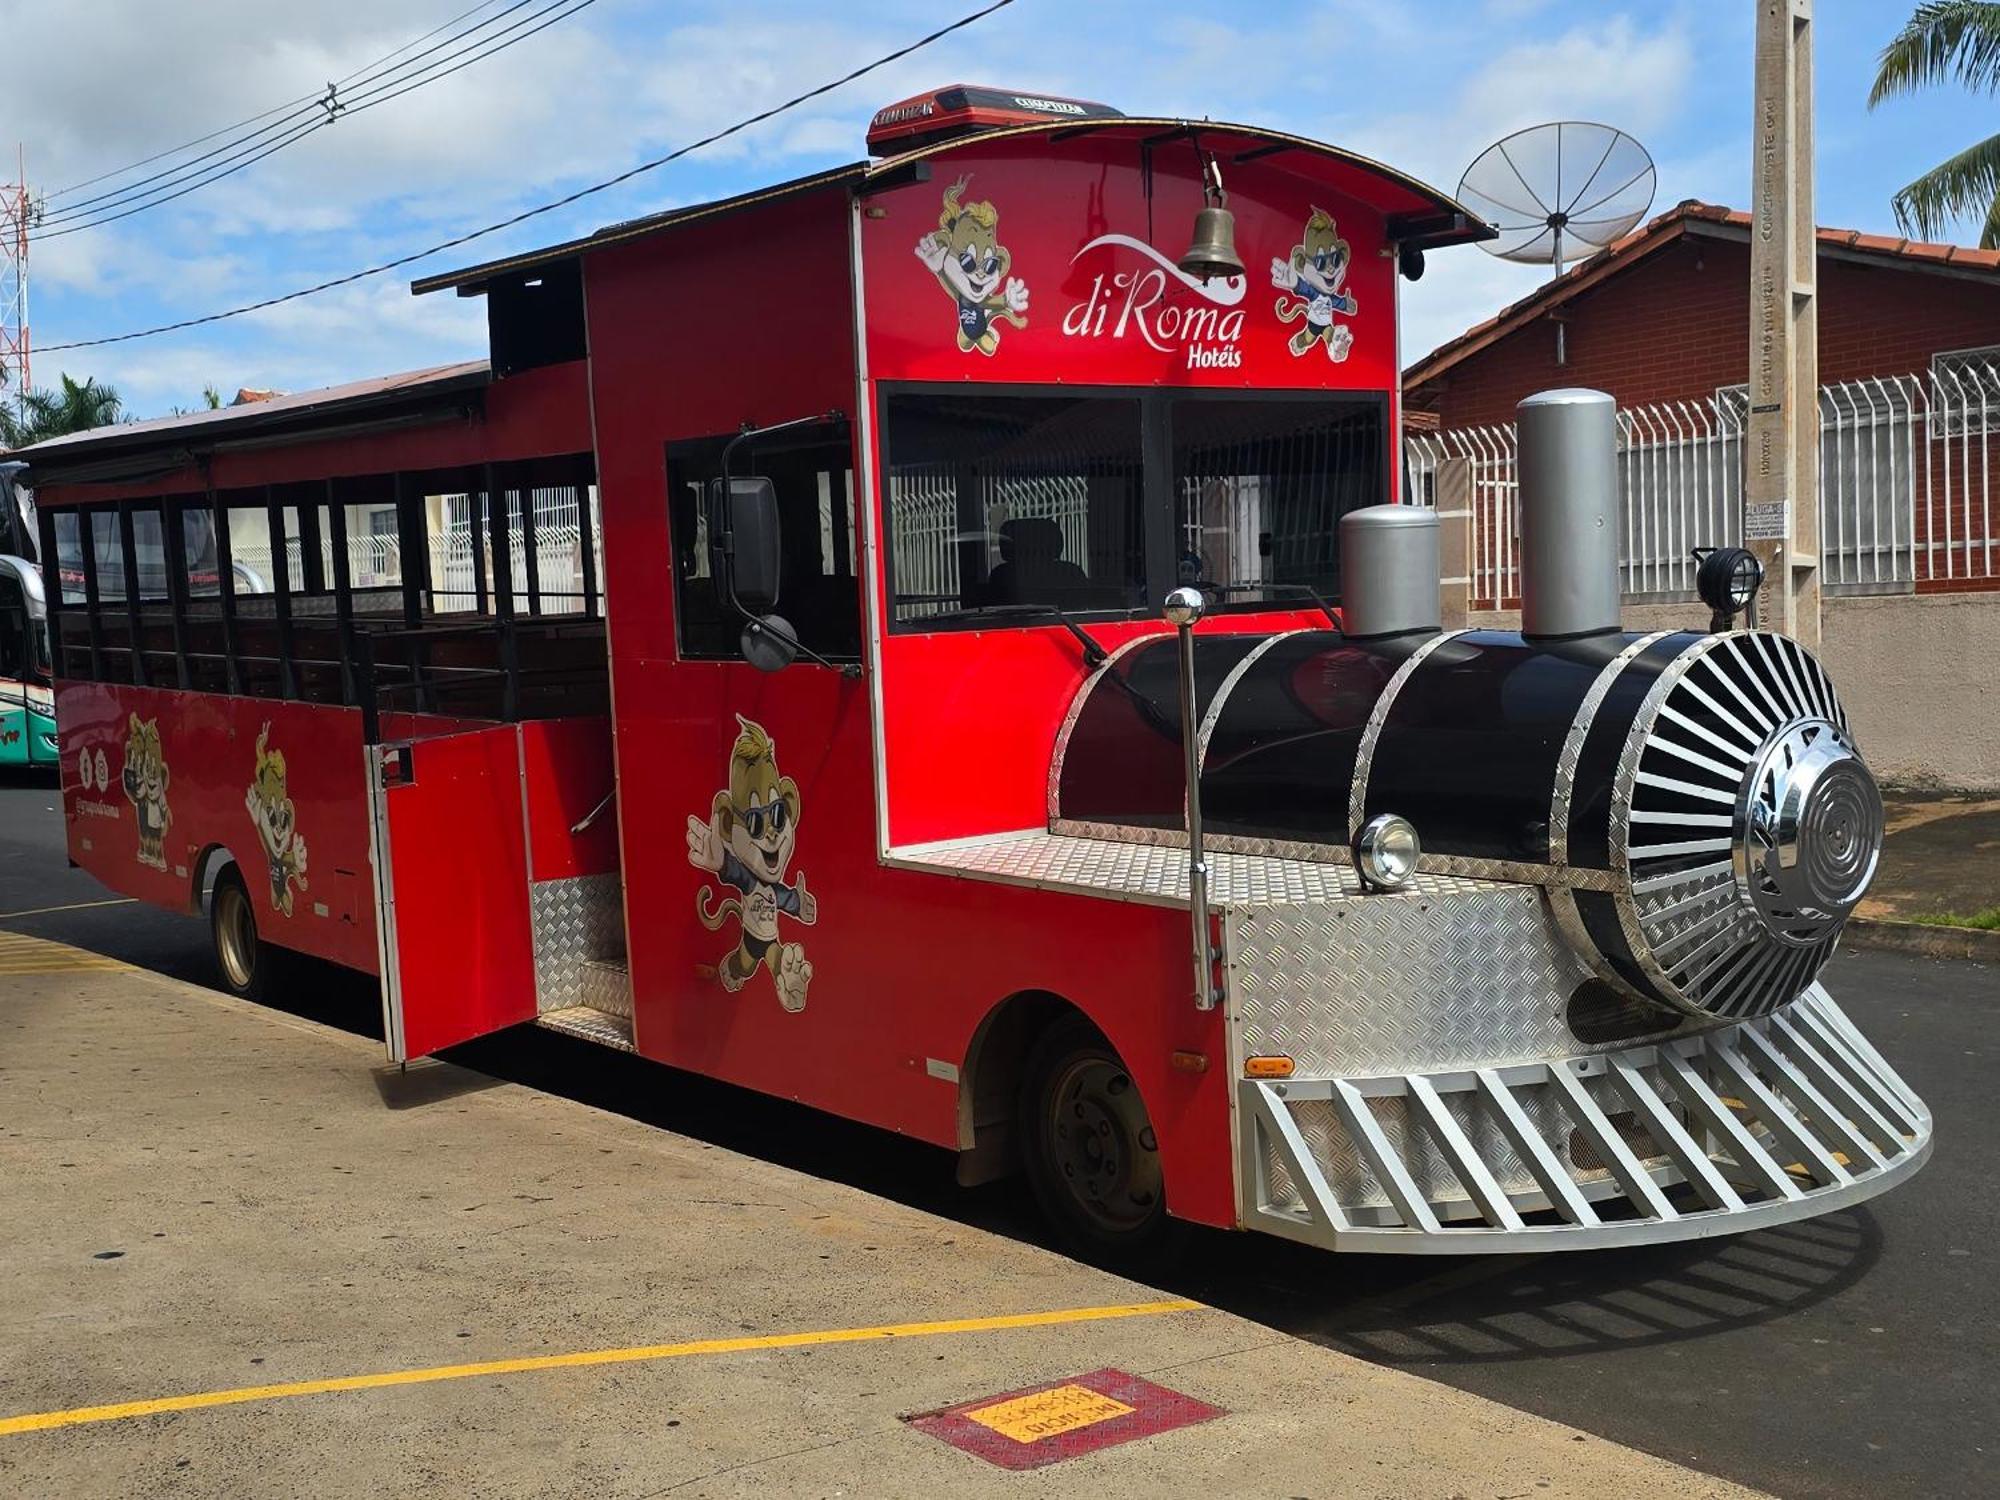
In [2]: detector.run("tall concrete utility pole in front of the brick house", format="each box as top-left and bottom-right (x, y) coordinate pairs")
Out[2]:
(1744, 0), (1820, 650)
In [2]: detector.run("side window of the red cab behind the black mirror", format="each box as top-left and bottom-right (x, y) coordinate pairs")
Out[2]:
(666, 426), (862, 662)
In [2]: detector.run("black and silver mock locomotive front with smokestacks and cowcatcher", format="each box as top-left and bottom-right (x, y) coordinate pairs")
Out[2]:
(1050, 392), (1932, 1252)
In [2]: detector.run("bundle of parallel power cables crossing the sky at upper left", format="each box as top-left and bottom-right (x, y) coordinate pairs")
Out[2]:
(36, 0), (596, 240)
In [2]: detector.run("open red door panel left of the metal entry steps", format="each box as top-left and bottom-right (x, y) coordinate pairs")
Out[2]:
(382, 724), (536, 1058)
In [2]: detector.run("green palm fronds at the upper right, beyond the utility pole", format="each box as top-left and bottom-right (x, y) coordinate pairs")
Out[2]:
(1868, 0), (2000, 250)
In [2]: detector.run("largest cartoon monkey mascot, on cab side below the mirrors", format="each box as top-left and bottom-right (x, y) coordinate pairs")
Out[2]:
(688, 714), (820, 1012)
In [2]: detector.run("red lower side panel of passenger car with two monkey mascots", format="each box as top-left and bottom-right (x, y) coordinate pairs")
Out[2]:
(56, 682), (376, 972)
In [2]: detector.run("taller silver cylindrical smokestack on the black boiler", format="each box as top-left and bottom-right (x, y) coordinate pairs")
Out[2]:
(1516, 390), (1620, 638)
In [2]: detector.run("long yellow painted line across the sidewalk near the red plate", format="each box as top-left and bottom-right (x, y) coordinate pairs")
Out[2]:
(0, 1298), (1202, 1436)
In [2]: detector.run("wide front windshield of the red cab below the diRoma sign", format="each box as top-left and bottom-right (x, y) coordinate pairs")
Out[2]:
(882, 388), (1386, 630)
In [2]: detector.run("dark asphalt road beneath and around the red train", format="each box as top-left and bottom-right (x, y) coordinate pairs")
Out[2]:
(0, 778), (2000, 1500)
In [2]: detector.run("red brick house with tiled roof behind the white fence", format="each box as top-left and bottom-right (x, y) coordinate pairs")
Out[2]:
(1404, 200), (2000, 596)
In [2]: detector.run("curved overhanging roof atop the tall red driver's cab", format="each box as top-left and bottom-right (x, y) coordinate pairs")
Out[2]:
(410, 116), (1494, 296)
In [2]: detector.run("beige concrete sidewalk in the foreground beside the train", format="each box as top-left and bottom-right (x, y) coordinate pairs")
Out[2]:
(0, 938), (1746, 1500)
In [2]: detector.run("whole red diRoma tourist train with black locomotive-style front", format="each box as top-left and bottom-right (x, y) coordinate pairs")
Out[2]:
(11, 88), (1930, 1252)
